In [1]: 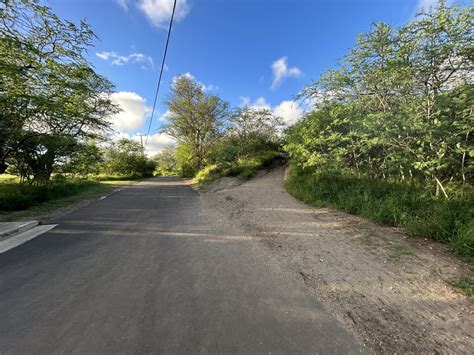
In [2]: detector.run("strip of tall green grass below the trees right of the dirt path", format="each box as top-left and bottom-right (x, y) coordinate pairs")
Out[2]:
(286, 167), (474, 261)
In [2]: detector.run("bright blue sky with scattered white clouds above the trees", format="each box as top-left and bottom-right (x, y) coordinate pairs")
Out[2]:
(48, 0), (466, 153)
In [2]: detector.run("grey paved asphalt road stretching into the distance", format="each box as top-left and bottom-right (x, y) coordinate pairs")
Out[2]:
(0, 178), (366, 354)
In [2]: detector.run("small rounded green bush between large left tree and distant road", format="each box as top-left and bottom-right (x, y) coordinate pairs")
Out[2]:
(105, 138), (156, 176)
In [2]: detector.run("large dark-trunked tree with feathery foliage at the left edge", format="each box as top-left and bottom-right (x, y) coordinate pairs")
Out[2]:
(0, 0), (117, 184)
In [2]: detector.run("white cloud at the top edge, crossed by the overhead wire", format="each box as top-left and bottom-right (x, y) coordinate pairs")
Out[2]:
(137, 0), (189, 28)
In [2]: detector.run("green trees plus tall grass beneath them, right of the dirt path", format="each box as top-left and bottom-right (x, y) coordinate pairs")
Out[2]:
(285, 1), (474, 258)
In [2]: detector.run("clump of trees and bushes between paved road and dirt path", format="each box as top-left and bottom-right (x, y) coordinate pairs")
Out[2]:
(154, 76), (282, 187)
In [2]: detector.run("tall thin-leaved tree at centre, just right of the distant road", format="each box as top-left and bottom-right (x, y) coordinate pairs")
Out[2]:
(163, 76), (229, 170)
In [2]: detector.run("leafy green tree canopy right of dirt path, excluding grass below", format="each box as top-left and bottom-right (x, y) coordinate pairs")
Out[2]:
(285, 1), (474, 196)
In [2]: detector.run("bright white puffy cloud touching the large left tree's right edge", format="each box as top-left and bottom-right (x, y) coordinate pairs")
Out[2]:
(110, 91), (151, 132)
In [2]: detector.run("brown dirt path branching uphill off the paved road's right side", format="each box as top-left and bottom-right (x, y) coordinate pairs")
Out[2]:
(202, 168), (474, 353)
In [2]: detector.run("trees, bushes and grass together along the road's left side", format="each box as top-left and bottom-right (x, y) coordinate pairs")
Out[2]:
(0, 0), (155, 212)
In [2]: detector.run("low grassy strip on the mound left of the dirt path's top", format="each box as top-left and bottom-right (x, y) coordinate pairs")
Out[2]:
(193, 152), (278, 188)
